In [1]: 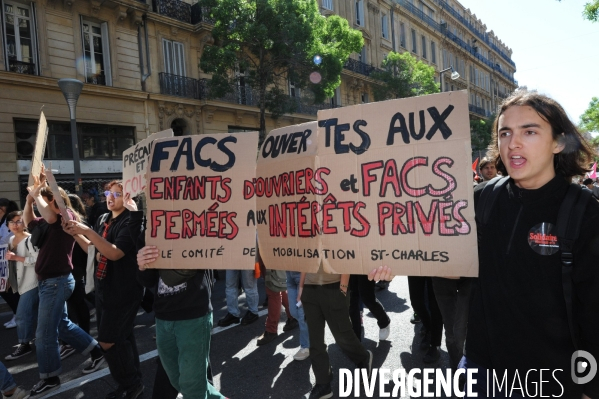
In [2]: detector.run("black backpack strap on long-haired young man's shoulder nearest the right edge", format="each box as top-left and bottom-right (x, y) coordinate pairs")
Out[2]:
(556, 183), (592, 349)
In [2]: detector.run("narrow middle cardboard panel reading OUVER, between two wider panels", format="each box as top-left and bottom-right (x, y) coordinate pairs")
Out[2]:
(254, 122), (323, 270)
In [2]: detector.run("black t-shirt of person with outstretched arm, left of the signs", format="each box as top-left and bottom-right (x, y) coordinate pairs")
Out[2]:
(95, 209), (143, 308)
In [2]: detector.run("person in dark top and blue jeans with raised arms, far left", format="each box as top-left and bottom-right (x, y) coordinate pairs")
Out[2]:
(23, 167), (104, 399)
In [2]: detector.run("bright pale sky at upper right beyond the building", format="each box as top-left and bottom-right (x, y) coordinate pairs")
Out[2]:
(458, 0), (599, 130)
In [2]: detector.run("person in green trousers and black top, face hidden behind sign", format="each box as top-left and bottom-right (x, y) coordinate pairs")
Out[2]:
(125, 196), (225, 399)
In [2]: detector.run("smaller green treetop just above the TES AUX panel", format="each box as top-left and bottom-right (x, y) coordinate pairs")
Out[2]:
(370, 51), (439, 101)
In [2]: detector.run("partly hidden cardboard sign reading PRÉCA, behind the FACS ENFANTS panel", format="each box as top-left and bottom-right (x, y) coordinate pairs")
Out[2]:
(123, 129), (173, 198)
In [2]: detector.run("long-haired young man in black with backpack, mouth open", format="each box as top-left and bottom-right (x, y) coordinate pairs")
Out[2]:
(369, 90), (599, 399)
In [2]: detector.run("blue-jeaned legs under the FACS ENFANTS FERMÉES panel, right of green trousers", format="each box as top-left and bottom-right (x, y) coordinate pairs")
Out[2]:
(218, 270), (259, 327)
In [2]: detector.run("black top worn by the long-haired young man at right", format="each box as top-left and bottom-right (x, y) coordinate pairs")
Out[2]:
(466, 176), (599, 399)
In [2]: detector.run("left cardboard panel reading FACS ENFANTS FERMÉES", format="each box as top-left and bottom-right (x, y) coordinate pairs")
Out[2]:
(145, 132), (258, 269)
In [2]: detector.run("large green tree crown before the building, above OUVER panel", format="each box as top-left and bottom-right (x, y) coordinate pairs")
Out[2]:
(200, 0), (363, 136)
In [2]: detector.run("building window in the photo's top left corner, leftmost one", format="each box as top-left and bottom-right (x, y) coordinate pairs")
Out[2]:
(2, 1), (38, 75)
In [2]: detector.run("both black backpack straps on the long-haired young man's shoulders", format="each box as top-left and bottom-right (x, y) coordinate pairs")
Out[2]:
(476, 176), (592, 349)
